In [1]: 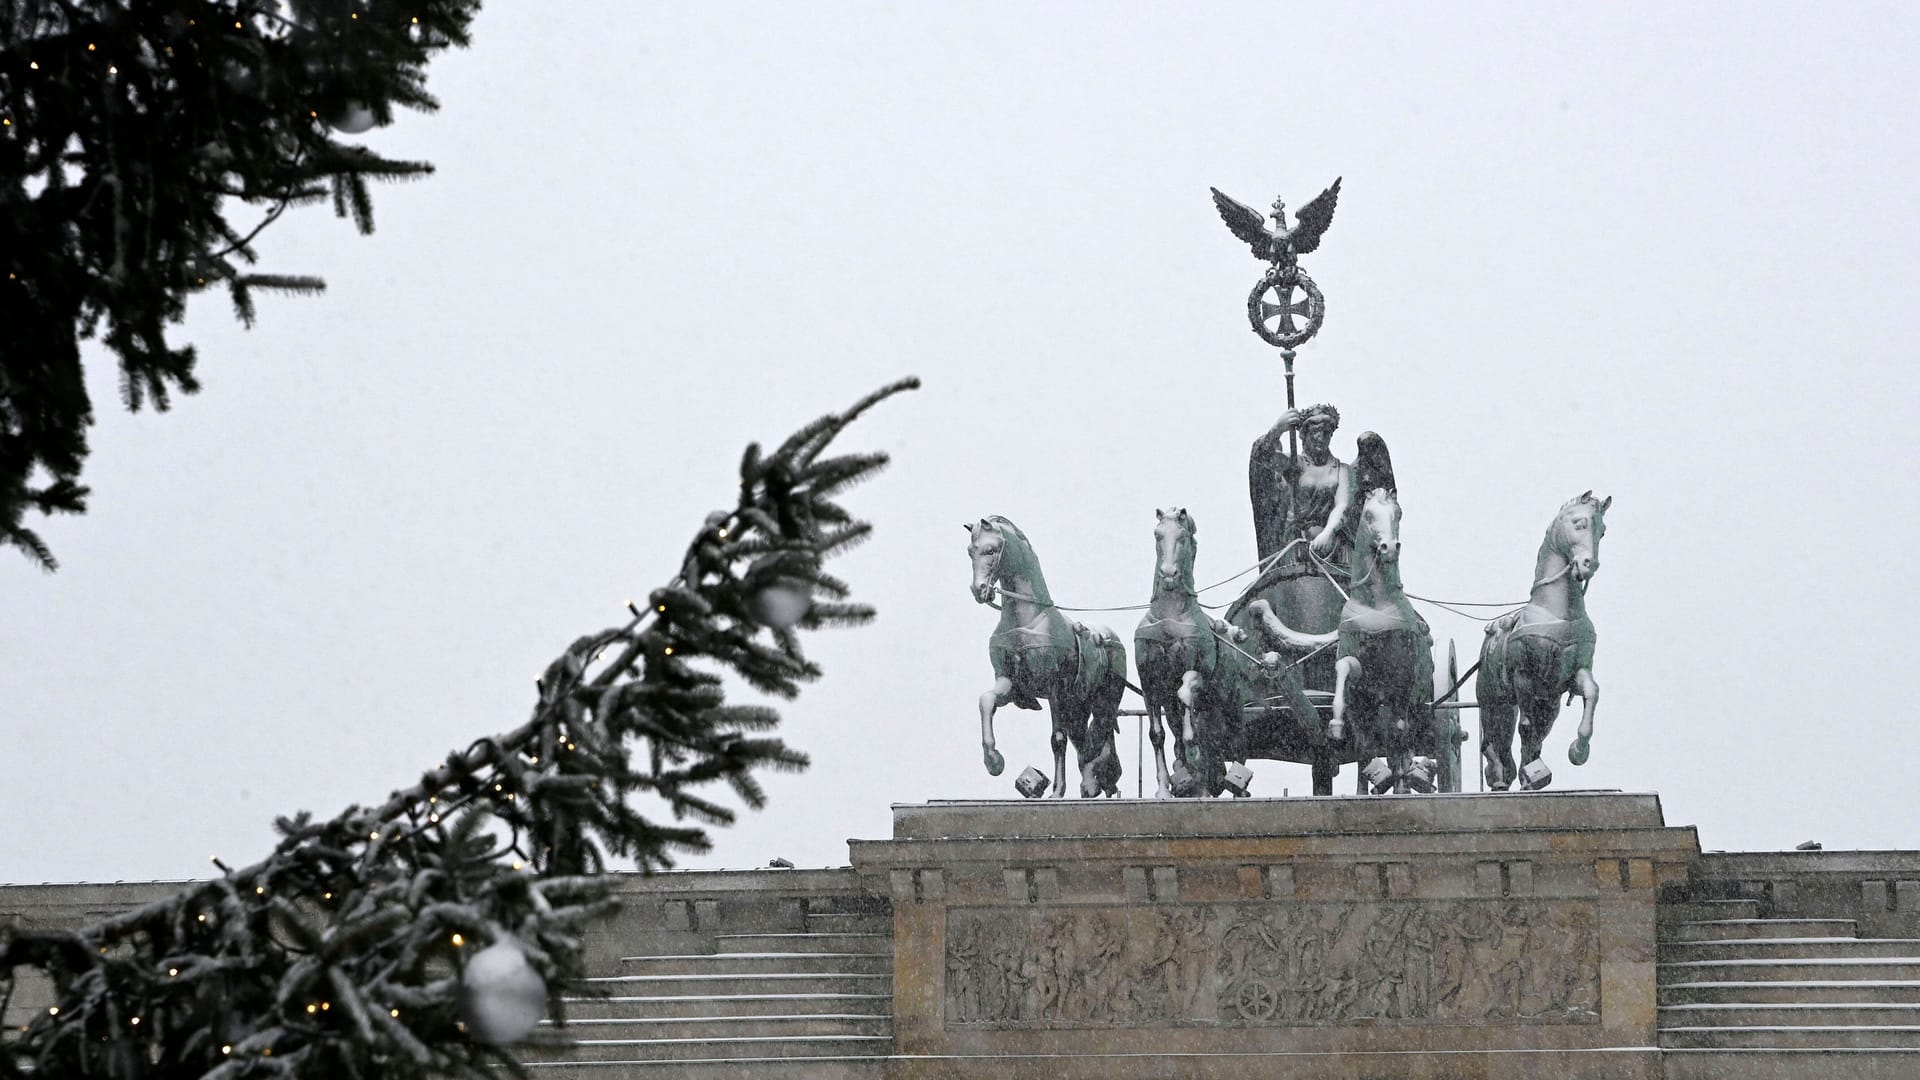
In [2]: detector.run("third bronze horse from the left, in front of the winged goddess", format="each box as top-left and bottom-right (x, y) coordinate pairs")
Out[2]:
(1248, 486), (1434, 792)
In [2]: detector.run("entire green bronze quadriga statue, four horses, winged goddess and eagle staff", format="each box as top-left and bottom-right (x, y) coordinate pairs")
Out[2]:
(966, 181), (1611, 795)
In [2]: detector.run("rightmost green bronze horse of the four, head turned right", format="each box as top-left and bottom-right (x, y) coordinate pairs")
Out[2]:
(1475, 492), (1613, 792)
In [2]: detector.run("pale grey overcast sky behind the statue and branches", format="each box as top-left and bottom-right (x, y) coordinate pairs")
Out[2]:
(0, 0), (1920, 882)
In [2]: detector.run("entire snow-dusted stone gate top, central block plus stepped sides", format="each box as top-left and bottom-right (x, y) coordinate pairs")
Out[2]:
(11, 792), (1920, 1080)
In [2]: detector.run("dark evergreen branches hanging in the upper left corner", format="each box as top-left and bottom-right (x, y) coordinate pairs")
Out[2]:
(0, 0), (480, 569)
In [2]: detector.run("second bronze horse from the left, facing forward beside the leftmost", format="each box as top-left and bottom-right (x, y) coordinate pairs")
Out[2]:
(1133, 507), (1281, 798)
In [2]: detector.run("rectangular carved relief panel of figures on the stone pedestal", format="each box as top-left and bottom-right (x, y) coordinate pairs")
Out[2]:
(945, 899), (1599, 1028)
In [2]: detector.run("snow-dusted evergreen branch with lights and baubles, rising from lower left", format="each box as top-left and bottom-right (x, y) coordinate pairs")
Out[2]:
(0, 379), (918, 1080)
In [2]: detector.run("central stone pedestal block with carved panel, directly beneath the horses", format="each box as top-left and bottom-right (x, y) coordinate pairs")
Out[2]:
(851, 792), (1699, 1076)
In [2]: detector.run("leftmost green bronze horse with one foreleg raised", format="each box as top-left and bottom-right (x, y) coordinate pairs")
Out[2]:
(964, 515), (1127, 798)
